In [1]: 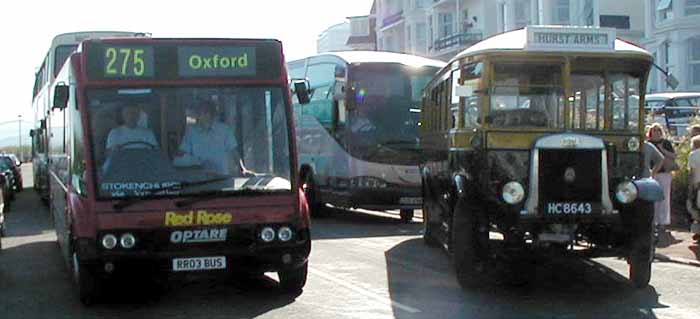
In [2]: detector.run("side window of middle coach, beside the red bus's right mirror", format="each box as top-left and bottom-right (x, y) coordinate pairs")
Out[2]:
(302, 63), (335, 128)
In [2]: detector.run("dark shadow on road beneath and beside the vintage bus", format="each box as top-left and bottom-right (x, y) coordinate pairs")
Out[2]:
(385, 239), (667, 318)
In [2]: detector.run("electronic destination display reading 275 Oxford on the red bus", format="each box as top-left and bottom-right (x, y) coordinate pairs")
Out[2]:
(86, 40), (282, 80)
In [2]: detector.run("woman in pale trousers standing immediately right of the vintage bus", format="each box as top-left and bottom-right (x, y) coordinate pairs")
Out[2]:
(647, 123), (679, 233)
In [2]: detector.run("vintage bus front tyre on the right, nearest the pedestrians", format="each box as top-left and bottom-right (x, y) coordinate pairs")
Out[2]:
(627, 202), (655, 288)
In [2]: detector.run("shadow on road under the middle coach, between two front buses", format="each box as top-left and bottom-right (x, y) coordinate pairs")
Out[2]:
(311, 208), (423, 240)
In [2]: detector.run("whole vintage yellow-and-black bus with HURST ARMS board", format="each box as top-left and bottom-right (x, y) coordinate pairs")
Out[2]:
(421, 26), (662, 288)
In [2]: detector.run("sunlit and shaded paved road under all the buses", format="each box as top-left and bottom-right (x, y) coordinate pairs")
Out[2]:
(0, 164), (700, 318)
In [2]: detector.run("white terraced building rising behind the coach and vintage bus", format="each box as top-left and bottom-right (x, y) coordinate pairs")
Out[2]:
(375, 0), (644, 60)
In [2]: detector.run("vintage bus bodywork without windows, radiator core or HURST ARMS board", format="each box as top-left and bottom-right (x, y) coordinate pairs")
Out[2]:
(421, 29), (660, 285)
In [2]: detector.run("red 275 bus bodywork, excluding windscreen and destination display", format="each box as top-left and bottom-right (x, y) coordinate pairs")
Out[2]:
(48, 38), (311, 302)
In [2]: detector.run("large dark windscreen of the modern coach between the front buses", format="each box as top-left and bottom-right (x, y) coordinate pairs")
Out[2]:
(349, 63), (438, 164)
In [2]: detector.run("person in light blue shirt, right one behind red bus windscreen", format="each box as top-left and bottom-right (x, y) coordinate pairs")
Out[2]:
(175, 100), (243, 175)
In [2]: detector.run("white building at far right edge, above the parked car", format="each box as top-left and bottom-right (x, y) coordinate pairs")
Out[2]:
(643, 0), (700, 92)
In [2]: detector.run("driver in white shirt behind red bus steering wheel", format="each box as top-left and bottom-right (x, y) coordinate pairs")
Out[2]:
(105, 104), (158, 156)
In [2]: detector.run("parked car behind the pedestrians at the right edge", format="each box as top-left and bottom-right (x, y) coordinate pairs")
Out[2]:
(644, 92), (700, 136)
